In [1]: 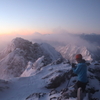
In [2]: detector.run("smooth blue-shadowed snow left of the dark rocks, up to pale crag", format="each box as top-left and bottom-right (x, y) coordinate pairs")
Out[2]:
(0, 57), (71, 100)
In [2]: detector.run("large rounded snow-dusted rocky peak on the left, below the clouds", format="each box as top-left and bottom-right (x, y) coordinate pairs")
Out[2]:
(0, 38), (62, 79)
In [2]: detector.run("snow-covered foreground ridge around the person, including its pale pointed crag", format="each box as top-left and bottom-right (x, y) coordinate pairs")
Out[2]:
(0, 57), (100, 100)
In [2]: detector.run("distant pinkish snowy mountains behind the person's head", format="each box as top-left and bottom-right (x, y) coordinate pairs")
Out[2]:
(55, 44), (100, 62)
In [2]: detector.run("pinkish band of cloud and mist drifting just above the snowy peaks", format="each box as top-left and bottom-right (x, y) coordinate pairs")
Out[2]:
(0, 30), (95, 50)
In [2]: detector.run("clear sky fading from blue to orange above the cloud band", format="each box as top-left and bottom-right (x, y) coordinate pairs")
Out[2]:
(0, 0), (100, 34)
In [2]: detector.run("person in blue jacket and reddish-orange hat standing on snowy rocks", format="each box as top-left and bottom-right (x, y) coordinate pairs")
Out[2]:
(73, 54), (88, 92)
